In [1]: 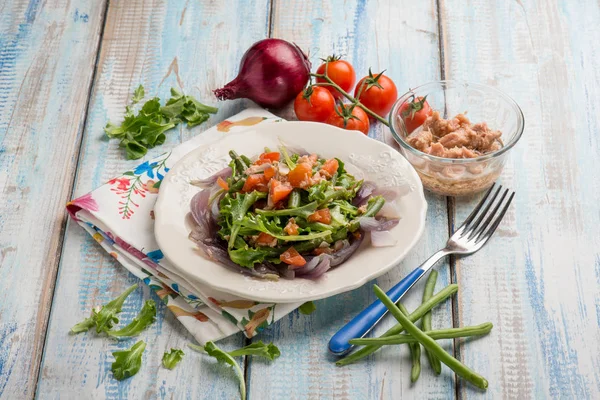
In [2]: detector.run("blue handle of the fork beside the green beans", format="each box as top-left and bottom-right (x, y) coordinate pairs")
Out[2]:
(329, 268), (427, 355)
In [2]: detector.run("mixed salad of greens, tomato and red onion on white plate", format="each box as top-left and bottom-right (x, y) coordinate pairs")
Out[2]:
(189, 146), (399, 280)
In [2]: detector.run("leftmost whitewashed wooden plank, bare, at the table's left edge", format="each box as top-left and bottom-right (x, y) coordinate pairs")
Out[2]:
(0, 0), (105, 399)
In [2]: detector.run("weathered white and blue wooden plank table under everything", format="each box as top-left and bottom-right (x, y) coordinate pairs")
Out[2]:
(0, 0), (600, 400)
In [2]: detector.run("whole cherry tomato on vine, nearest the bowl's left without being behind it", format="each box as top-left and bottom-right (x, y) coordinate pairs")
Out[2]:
(354, 70), (398, 117)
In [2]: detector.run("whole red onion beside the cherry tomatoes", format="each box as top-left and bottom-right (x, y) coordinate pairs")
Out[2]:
(214, 38), (311, 108)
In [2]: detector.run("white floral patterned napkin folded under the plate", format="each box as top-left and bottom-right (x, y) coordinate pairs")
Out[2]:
(67, 108), (300, 343)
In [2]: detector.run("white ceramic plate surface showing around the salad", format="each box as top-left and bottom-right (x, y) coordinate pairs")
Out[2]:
(155, 122), (427, 303)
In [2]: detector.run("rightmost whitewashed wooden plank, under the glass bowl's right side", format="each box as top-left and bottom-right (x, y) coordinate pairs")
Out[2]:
(440, 0), (600, 399)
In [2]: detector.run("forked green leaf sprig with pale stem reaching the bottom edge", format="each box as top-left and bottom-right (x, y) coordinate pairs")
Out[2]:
(188, 341), (281, 400)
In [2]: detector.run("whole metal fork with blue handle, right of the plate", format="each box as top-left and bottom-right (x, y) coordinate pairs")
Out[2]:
(329, 184), (515, 356)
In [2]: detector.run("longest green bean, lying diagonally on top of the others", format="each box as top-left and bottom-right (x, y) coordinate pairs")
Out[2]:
(373, 285), (488, 389)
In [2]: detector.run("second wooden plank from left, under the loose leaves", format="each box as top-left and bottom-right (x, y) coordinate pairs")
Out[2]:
(38, 0), (269, 399)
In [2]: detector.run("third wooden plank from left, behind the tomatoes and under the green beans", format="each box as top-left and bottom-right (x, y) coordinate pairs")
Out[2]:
(249, 1), (454, 399)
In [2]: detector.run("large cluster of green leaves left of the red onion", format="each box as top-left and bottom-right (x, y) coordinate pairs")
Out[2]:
(104, 85), (217, 159)
